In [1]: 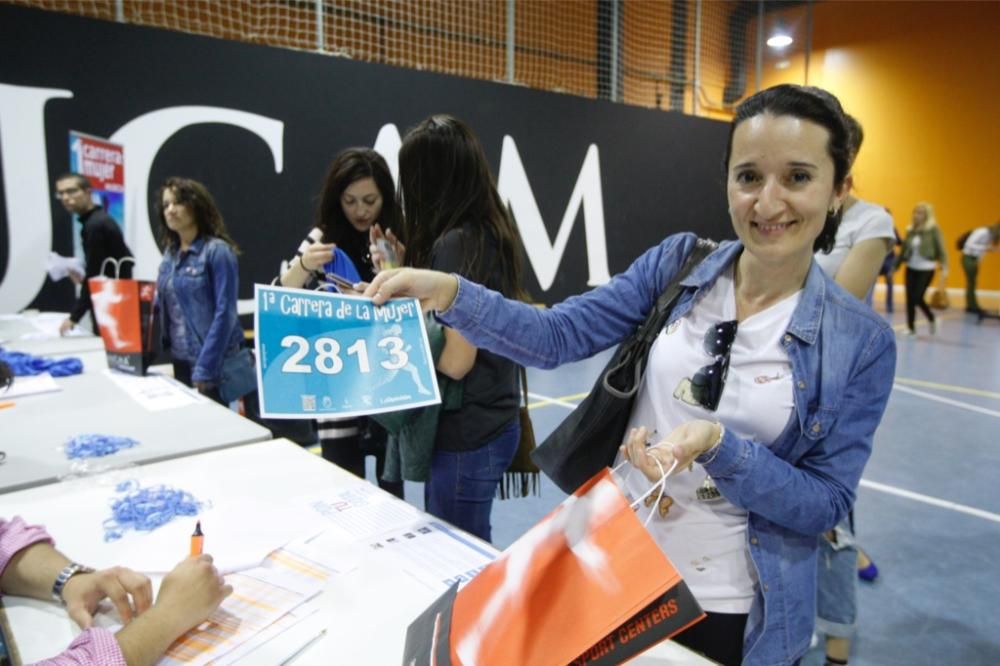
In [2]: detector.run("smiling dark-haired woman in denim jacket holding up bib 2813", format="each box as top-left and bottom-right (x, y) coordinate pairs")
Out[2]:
(366, 85), (896, 666)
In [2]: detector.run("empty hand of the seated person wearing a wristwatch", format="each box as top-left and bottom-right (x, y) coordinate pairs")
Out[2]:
(63, 567), (153, 629)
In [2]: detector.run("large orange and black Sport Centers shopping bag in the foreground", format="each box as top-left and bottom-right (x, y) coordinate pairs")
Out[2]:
(403, 469), (704, 666)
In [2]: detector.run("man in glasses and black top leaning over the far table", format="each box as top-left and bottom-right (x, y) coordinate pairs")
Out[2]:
(56, 173), (132, 335)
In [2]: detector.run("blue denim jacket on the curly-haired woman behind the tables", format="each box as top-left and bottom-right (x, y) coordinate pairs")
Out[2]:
(156, 236), (243, 384)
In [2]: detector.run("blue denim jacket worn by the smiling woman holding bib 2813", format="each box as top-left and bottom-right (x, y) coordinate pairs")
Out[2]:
(438, 234), (896, 666)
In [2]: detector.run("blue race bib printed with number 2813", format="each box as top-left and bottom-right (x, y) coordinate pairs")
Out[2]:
(254, 285), (440, 418)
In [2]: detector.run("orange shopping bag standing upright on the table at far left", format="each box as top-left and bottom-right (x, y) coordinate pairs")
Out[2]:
(87, 257), (156, 375)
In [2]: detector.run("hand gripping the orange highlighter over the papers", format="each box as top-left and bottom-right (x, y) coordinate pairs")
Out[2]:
(156, 554), (233, 636)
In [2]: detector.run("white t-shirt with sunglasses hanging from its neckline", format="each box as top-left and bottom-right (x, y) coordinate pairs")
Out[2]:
(618, 268), (801, 613)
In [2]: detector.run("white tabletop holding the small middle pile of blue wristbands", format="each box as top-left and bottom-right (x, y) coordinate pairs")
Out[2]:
(0, 366), (271, 493)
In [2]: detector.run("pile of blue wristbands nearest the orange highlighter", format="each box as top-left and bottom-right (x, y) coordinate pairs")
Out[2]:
(104, 480), (204, 542)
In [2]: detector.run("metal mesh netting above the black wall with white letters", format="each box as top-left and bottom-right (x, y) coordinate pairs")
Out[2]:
(0, 0), (804, 116)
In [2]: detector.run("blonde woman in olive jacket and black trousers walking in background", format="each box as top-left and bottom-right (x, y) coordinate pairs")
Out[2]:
(899, 202), (948, 335)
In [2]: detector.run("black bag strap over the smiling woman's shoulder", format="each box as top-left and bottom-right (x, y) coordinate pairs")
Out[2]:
(603, 238), (719, 398)
